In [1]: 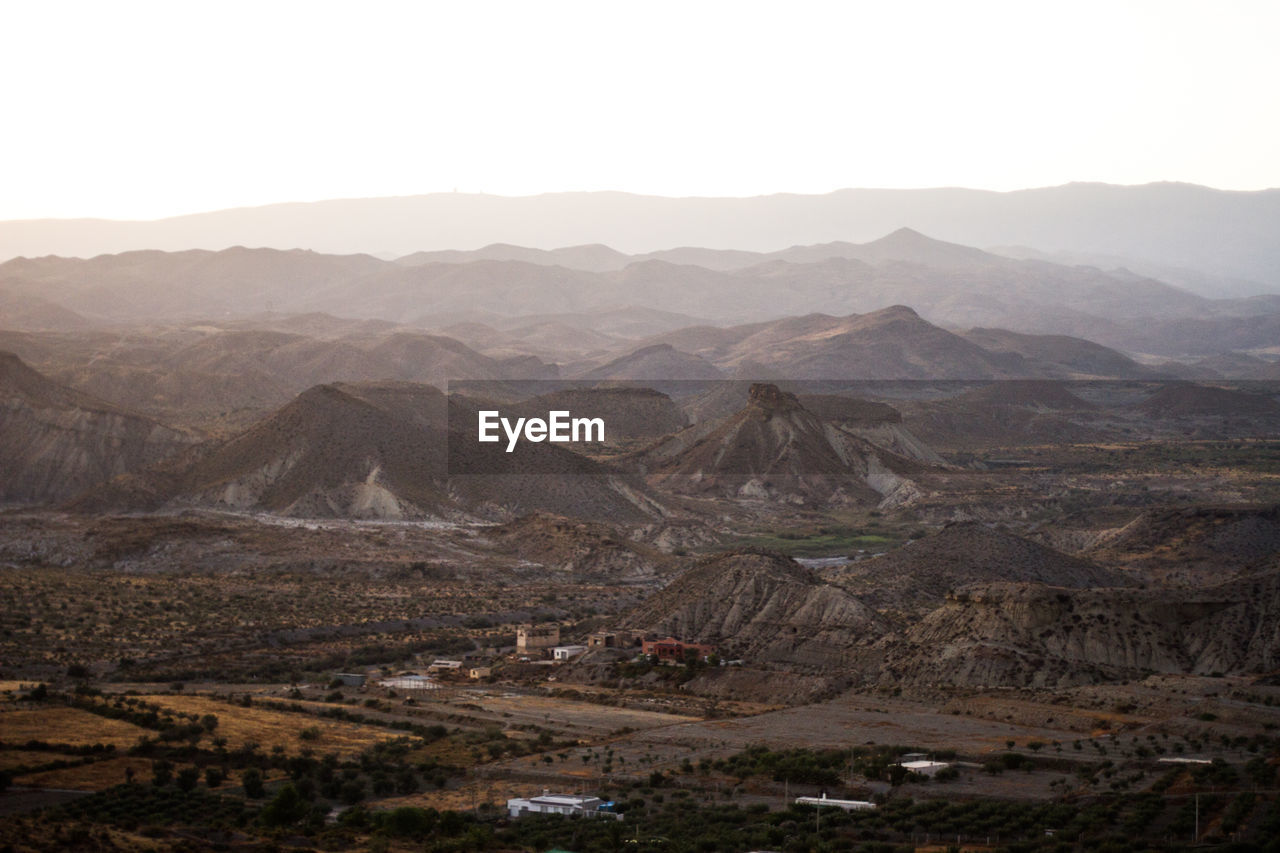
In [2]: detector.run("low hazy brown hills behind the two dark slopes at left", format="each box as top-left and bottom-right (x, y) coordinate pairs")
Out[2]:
(0, 322), (558, 428)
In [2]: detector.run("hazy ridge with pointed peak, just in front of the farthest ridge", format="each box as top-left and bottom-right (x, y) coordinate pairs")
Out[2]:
(10, 220), (1280, 353)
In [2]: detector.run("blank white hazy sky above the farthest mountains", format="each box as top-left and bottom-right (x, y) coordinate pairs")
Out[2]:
(0, 0), (1280, 219)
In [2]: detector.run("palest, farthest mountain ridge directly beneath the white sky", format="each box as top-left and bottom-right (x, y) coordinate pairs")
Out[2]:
(0, 183), (1280, 295)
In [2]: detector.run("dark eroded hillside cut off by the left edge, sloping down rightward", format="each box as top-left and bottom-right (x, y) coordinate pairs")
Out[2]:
(0, 352), (195, 503)
